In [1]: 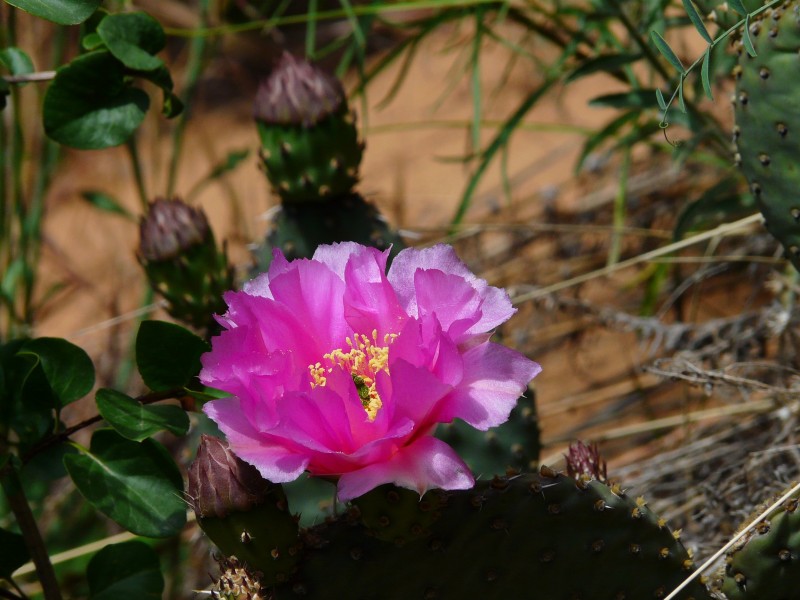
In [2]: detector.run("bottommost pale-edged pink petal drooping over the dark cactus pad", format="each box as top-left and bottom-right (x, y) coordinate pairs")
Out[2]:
(338, 436), (475, 502)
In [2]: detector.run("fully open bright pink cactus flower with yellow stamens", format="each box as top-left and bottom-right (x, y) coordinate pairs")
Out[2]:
(200, 243), (541, 501)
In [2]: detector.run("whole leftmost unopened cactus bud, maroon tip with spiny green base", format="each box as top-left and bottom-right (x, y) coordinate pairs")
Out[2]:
(138, 198), (233, 331)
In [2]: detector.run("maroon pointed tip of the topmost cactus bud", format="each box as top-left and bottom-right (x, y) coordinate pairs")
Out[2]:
(253, 52), (345, 127)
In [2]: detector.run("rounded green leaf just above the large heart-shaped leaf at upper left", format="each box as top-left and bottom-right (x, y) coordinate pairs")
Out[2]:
(97, 12), (166, 71)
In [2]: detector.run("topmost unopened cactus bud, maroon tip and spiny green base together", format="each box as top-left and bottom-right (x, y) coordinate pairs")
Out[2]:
(253, 53), (364, 203)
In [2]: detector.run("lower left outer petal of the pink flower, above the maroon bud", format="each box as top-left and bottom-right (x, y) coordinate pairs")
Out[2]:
(203, 398), (309, 483)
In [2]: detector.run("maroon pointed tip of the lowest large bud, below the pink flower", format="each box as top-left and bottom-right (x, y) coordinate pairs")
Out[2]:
(187, 435), (274, 518)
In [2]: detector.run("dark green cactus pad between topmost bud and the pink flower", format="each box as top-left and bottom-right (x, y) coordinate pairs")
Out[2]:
(254, 194), (405, 271)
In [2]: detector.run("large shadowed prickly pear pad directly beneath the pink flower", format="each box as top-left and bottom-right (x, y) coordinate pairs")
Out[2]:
(284, 469), (710, 600)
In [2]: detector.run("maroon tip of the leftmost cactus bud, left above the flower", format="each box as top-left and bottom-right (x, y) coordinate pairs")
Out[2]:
(139, 198), (209, 261)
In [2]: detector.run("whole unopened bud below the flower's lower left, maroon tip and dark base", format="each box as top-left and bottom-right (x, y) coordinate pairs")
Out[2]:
(186, 435), (302, 585)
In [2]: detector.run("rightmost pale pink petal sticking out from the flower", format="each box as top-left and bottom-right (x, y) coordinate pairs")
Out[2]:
(436, 342), (542, 431)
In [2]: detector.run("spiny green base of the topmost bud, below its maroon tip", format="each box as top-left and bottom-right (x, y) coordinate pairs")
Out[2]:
(256, 102), (364, 204)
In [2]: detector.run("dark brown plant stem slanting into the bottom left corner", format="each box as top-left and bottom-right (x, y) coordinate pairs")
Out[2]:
(0, 465), (61, 600)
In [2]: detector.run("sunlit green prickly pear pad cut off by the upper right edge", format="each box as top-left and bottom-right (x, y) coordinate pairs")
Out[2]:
(733, 0), (800, 269)
